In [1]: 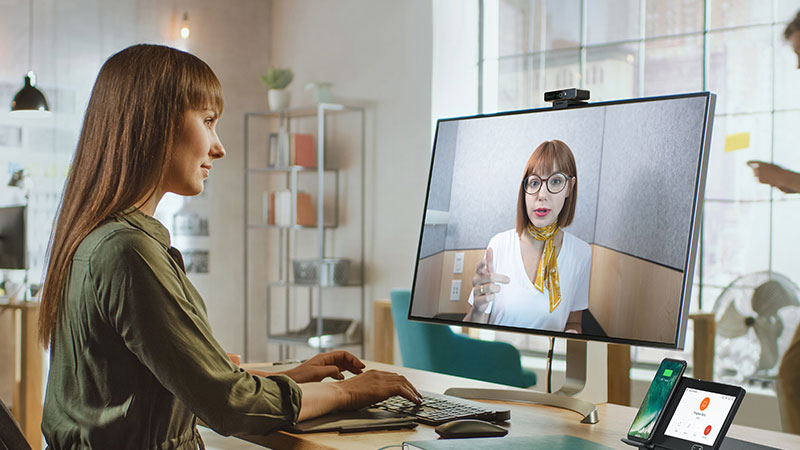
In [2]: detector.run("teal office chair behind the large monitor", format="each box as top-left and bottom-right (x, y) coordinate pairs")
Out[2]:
(391, 289), (536, 388)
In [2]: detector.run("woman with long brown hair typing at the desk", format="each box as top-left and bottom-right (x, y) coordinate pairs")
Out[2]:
(39, 45), (420, 449)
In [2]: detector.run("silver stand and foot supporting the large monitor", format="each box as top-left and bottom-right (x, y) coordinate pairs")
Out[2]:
(444, 339), (599, 423)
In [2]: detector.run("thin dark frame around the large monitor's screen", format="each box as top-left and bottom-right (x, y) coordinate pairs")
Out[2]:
(407, 91), (716, 350)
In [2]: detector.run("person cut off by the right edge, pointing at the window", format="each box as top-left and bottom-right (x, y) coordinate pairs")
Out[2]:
(747, 11), (800, 434)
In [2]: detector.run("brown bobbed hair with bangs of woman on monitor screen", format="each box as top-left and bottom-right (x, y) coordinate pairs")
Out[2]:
(517, 139), (578, 234)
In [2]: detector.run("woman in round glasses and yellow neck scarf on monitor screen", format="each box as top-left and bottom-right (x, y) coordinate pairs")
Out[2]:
(464, 140), (592, 333)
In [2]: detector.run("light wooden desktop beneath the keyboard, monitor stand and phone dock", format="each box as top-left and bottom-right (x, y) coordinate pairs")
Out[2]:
(198, 361), (800, 450)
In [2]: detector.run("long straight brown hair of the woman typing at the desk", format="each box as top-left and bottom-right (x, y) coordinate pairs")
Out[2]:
(39, 44), (223, 348)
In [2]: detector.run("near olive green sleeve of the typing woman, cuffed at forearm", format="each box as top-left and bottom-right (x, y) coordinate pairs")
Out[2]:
(89, 230), (301, 435)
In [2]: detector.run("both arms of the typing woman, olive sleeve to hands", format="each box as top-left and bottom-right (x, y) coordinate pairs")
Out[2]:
(96, 231), (421, 435)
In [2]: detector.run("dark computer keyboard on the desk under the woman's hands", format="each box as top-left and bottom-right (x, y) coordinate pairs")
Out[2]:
(372, 391), (511, 426)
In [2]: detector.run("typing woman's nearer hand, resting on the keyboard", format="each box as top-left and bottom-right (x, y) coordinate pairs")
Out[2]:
(336, 370), (422, 409)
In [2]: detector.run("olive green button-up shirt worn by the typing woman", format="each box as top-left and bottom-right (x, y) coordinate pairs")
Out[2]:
(42, 208), (301, 450)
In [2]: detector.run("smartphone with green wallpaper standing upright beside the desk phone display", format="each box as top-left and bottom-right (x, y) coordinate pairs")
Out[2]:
(628, 359), (686, 441)
